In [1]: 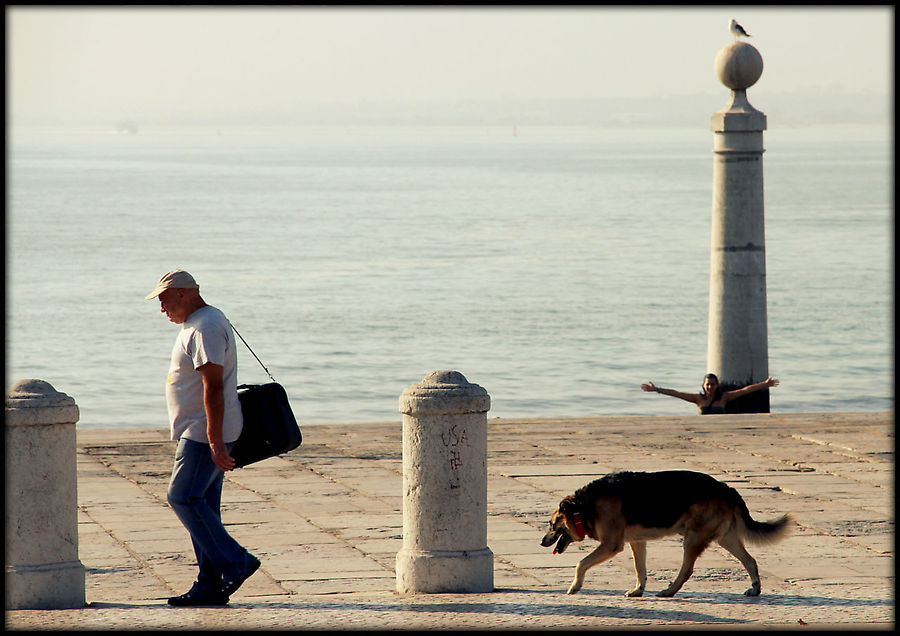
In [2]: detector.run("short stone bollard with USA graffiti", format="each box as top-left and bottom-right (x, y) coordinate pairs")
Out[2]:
(397, 371), (494, 594)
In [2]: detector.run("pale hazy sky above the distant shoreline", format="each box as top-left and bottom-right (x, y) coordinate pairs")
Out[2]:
(6, 6), (894, 124)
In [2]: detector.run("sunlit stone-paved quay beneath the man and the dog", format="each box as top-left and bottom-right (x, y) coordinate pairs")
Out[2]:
(5, 411), (895, 631)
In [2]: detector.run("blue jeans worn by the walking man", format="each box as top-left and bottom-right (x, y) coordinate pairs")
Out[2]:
(166, 437), (254, 593)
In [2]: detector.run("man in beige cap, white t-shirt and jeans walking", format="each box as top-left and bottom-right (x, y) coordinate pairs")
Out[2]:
(147, 269), (260, 607)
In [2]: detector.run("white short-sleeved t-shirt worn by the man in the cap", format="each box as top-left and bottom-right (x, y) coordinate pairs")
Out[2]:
(166, 305), (244, 444)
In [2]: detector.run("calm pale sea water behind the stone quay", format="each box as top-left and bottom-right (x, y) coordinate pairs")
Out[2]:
(6, 126), (894, 428)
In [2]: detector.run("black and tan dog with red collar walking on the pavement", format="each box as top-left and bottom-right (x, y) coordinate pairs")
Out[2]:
(541, 470), (791, 596)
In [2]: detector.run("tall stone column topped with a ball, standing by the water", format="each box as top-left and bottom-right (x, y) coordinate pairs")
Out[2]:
(707, 42), (769, 413)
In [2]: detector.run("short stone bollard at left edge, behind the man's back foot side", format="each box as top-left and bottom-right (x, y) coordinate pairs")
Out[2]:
(5, 380), (85, 610)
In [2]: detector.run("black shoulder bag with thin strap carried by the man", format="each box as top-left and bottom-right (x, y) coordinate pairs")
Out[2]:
(231, 325), (303, 468)
